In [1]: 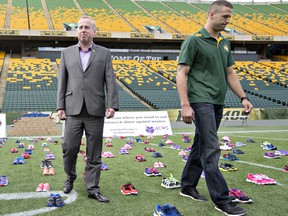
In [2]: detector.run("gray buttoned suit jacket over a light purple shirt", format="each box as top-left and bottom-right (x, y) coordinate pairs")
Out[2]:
(57, 43), (119, 116)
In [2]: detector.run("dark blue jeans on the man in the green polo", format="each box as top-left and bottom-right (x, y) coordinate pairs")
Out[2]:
(181, 103), (230, 205)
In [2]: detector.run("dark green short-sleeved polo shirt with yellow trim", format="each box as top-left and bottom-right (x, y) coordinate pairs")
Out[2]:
(178, 28), (234, 105)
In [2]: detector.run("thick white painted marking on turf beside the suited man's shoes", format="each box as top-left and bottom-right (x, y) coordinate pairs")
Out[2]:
(0, 190), (77, 216)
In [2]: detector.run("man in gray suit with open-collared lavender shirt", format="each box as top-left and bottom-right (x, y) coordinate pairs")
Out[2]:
(57, 16), (119, 202)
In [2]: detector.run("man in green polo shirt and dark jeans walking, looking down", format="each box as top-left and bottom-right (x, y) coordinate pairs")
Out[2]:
(176, 0), (253, 215)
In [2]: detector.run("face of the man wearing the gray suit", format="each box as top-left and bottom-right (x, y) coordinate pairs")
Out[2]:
(77, 18), (96, 44)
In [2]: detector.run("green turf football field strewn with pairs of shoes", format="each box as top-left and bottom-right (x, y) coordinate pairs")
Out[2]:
(0, 125), (288, 216)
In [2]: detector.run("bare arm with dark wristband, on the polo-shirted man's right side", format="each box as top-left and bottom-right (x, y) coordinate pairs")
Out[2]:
(227, 66), (253, 113)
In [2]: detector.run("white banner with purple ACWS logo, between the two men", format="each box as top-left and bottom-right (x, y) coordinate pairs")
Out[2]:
(103, 111), (172, 137)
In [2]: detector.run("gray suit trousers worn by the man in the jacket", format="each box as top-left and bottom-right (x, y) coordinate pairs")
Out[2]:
(62, 105), (104, 194)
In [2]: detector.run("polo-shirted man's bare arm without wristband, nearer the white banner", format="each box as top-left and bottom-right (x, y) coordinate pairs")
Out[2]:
(176, 64), (195, 124)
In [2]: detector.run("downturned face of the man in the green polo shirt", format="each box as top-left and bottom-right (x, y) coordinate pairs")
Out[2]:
(211, 7), (232, 32)
